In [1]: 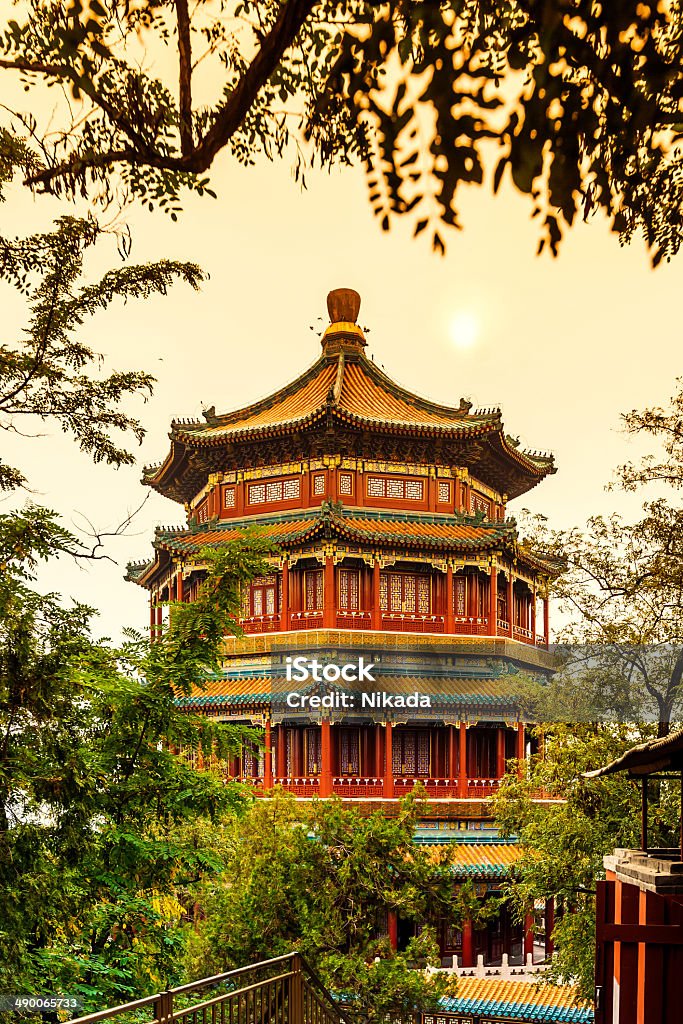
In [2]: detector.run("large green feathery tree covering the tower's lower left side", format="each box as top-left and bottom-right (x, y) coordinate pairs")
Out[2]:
(0, 507), (278, 1010)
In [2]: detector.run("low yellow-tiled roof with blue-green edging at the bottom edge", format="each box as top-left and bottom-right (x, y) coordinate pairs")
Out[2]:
(444, 977), (594, 1024)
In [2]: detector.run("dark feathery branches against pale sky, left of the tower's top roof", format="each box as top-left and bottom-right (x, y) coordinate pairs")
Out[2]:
(0, 209), (203, 490)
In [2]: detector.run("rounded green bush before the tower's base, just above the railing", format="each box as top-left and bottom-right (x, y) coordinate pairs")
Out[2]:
(186, 792), (458, 1021)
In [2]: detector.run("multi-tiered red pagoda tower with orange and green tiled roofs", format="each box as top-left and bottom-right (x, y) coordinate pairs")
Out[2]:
(128, 289), (556, 965)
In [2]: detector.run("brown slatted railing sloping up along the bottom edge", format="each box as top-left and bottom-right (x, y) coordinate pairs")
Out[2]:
(70, 953), (349, 1024)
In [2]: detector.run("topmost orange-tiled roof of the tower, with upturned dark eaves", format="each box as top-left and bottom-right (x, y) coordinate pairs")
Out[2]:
(143, 293), (555, 500)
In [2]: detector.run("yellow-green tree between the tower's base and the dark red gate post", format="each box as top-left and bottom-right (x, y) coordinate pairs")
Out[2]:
(495, 724), (680, 1000)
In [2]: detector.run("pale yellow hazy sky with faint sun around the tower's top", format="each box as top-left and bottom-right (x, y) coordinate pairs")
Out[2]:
(0, 59), (683, 635)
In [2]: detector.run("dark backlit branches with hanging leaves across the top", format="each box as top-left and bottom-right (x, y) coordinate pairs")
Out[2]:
(0, 0), (683, 263)
